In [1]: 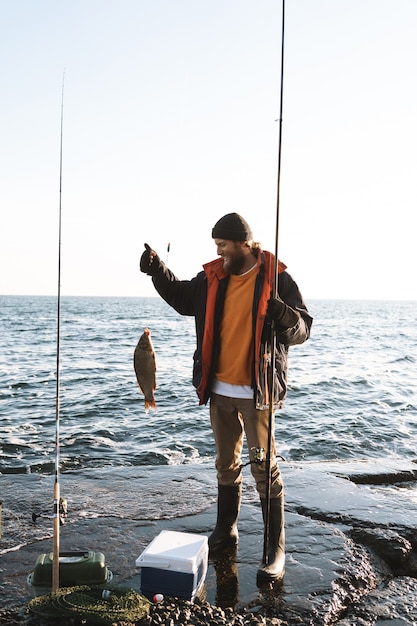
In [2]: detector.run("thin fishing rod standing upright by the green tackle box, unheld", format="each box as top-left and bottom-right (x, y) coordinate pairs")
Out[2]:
(52, 74), (65, 591)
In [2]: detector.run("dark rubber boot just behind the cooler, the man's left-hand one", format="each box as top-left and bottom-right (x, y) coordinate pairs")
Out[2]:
(209, 485), (242, 553)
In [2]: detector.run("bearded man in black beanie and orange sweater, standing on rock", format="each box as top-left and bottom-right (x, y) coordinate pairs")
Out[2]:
(140, 213), (312, 585)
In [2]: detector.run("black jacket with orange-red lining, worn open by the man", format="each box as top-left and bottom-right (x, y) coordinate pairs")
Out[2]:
(152, 250), (312, 409)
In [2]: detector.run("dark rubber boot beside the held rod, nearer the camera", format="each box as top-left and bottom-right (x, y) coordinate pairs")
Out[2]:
(256, 493), (285, 587)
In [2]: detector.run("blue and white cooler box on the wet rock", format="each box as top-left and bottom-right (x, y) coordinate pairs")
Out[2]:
(136, 530), (208, 602)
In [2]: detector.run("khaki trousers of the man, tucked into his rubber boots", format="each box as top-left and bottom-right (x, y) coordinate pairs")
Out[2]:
(210, 393), (283, 498)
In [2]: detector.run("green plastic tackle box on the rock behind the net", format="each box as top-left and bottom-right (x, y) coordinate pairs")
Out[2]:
(28, 550), (113, 594)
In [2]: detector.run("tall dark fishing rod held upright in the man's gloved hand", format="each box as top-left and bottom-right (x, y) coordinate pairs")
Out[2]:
(263, 0), (285, 565)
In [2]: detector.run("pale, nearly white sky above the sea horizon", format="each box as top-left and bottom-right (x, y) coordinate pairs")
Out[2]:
(0, 0), (417, 301)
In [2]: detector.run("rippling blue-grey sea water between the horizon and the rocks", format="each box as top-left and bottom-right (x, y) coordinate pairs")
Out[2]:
(0, 296), (417, 474)
